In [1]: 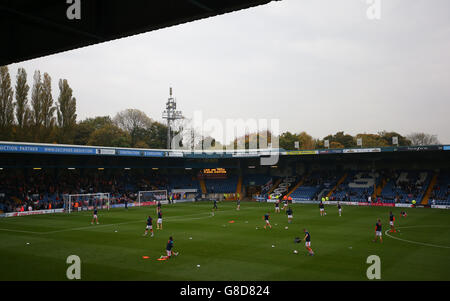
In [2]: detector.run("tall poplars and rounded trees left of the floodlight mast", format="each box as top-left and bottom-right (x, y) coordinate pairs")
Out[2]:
(0, 66), (167, 148)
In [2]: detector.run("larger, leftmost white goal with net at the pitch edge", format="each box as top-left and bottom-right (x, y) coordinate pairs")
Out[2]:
(63, 192), (110, 213)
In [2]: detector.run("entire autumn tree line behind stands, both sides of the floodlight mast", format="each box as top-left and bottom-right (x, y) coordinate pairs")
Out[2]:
(0, 66), (440, 150)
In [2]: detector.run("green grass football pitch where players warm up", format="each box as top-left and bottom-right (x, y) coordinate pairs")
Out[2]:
(0, 202), (450, 281)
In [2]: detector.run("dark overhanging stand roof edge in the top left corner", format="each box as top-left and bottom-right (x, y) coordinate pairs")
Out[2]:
(0, 0), (280, 66)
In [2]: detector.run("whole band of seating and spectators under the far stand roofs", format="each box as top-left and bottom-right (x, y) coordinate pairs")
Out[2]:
(0, 169), (450, 212)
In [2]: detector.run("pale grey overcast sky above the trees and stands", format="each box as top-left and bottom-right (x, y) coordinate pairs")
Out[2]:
(10, 0), (450, 143)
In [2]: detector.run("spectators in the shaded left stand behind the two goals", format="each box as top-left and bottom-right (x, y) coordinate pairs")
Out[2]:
(0, 171), (172, 212)
